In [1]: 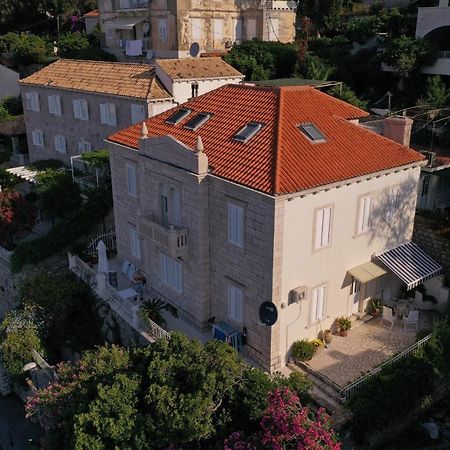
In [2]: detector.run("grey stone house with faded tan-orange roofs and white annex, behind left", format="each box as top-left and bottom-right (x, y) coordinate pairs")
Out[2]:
(20, 58), (243, 164)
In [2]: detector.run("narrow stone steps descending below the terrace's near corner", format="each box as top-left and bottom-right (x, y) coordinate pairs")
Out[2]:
(288, 363), (352, 430)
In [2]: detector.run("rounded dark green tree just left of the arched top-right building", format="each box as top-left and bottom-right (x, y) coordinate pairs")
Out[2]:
(382, 35), (437, 77)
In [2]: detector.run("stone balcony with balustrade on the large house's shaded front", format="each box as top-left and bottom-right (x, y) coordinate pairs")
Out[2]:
(139, 216), (189, 258)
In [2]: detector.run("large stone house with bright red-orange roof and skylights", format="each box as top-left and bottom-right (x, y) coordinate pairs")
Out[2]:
(108, 85), (439, 371)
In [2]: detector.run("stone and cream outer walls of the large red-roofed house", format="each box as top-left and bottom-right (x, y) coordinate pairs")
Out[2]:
(108, 128), (426, 371)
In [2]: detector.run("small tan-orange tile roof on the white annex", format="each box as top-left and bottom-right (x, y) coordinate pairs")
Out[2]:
(155, 58), (244, 80)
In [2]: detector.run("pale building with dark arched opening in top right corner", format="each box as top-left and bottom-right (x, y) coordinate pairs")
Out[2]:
(416, 0), (450, 75)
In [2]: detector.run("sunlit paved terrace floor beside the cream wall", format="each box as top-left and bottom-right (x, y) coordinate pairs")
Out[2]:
(306, 311), (432, 387)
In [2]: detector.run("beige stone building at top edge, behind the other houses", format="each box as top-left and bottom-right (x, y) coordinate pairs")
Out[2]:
(98, 0), (295, 60)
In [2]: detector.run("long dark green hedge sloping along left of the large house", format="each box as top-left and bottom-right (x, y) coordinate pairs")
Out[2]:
(11, 185), (112, 273)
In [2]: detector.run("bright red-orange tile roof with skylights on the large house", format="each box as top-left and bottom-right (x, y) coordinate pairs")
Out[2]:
(108, 85), (423, 194)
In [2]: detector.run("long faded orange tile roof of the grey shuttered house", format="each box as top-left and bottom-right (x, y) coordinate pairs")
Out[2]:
(19, 59), (172, 99)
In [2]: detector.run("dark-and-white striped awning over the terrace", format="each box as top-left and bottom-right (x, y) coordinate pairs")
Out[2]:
(374, 242), (442, 290)
